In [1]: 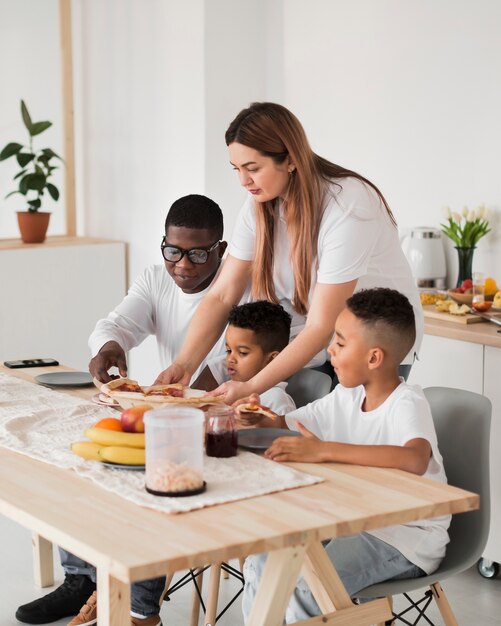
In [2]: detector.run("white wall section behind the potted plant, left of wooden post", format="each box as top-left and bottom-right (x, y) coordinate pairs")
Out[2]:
(0, 0), (65, 239)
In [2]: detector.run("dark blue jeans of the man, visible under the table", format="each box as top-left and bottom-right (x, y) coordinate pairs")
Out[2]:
(59, 548), (165, 617)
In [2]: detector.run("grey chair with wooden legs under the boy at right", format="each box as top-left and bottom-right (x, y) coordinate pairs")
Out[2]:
(356, 387), (492, 626)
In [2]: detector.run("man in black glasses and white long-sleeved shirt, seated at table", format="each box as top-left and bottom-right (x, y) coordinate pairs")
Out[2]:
(16, 195), (227, 626)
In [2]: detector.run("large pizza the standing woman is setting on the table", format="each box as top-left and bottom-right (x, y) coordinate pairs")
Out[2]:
(101, 378), (224, 407)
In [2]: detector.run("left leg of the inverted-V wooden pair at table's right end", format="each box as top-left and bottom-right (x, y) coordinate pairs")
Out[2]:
(247, 545), (306, 626)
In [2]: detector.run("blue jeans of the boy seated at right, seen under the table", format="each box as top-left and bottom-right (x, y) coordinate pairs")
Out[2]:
(242, 533), (425, 624)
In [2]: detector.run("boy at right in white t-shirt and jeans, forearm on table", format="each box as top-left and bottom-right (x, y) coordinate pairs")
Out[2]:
(237, 289), (450, 623)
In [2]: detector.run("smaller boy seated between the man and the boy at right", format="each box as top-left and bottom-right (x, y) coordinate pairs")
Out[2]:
(212, 300), (296, 415)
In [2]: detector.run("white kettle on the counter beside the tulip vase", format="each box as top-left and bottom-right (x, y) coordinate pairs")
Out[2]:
(400, 226), (446, 289)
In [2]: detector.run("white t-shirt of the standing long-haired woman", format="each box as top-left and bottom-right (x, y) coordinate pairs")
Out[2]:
(229, 177), (423, 363)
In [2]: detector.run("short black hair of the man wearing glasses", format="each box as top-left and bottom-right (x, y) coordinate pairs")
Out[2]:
(165, 194), (223, 239)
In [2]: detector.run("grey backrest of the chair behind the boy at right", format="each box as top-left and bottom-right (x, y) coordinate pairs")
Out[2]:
(424, 387), (492, 574)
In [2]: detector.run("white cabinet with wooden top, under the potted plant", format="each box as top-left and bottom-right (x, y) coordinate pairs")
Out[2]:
(0, 237), (126, 370)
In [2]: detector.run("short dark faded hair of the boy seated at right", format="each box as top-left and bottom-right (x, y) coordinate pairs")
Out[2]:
(346, 287), (416, 363)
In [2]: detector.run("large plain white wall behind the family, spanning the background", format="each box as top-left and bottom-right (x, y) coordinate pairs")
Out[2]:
(0, 0), (501, 382)
